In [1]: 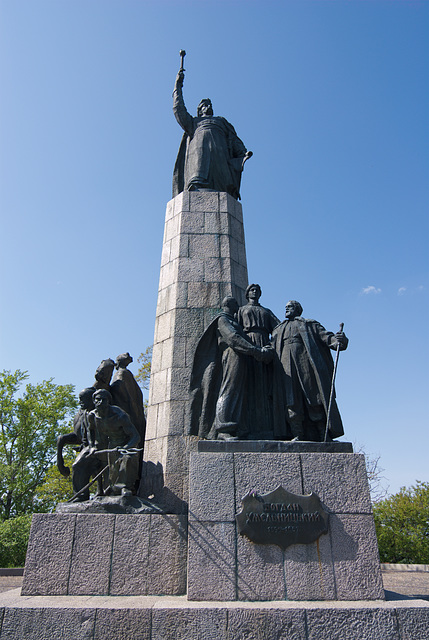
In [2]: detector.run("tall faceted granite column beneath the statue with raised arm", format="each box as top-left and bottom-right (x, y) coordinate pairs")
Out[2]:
(141, 191), (248, 513)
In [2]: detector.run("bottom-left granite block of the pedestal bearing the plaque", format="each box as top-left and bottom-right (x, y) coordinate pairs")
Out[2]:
(188, 521), (236, 600)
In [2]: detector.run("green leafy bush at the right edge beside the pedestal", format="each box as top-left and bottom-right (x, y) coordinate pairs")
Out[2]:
(373, 481), (429, 564)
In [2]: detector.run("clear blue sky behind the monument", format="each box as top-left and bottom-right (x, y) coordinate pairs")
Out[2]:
(0, 0), (429, 492)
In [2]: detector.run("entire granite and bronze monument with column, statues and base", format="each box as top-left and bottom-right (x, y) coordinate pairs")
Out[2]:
(5, 51), (429, 640)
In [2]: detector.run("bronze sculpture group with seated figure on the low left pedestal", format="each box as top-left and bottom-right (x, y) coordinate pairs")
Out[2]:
(57, 353), (146, 502)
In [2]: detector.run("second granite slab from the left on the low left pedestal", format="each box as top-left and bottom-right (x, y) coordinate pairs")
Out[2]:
(68, 514), (115, 596)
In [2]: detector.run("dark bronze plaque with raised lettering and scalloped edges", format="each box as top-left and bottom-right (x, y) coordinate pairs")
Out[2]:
(235, 486), (329, 549)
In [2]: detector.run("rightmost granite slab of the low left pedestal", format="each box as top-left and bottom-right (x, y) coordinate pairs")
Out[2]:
(147, 514), (187, 595)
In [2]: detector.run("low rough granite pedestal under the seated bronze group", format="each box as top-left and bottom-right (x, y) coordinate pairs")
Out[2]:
(23, 514), (187, 596)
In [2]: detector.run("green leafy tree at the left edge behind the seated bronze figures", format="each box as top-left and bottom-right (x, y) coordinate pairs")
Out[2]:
(0, 370), (77, 520)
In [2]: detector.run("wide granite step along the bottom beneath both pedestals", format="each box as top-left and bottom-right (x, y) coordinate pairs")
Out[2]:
(0, 589), (429, 640)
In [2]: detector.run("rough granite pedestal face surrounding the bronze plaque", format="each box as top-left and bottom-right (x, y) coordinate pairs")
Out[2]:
(188, 452), (384, 601)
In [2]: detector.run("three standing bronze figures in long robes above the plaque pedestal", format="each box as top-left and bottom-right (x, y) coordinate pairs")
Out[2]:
(187, 284), (348, 442)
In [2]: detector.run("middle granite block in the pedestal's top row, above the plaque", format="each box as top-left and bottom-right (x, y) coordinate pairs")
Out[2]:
(231, 453), (302, 512)
